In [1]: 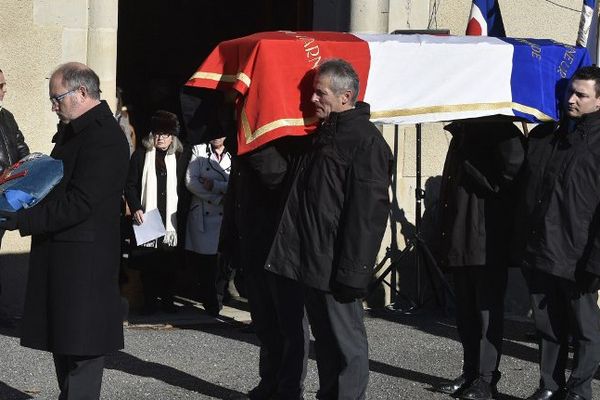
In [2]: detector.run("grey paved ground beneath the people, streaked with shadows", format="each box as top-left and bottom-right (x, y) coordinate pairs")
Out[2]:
(0, 296), (600, 400)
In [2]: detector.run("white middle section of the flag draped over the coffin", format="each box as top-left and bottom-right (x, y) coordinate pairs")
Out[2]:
(356, 34), (514, 124)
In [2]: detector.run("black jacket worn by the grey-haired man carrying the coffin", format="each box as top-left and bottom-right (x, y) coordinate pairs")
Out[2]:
(265, 102), (392, 291)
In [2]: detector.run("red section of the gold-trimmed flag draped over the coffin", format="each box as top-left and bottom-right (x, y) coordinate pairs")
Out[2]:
(186, 31), (371, 154)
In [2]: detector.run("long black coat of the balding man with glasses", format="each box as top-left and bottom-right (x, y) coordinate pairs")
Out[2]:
(18, 102), (129, 355)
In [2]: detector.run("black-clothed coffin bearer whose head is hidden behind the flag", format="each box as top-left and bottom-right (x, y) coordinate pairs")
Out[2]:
(436, 121), (525, 400)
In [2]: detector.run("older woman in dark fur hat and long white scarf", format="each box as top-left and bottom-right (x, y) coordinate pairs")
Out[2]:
(125, 110), (185, 314)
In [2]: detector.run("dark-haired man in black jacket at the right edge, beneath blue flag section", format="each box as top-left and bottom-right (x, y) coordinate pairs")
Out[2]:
(514, 67), (600, 400)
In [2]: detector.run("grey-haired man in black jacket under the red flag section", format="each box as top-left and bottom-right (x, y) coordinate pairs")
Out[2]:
(265, 60), (392, 400)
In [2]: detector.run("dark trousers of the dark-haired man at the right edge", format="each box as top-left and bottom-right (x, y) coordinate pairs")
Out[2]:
(524, 270), (600, 399)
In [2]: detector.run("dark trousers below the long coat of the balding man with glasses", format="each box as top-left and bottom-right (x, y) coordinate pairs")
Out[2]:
(52, 353), (104, 400)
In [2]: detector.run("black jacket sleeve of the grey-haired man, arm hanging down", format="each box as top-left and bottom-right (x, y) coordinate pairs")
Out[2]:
(333, 137), (392, 289)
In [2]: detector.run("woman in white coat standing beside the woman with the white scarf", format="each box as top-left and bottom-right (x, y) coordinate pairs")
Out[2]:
(185, 138), (231, 316)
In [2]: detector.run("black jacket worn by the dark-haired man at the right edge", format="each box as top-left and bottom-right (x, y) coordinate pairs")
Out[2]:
(513, 111), (600, 280)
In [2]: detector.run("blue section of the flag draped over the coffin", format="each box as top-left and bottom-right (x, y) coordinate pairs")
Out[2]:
(502, 38), (591, 122)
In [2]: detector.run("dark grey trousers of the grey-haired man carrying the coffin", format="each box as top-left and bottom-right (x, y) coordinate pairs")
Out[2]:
(306, 288), (369, 400)
